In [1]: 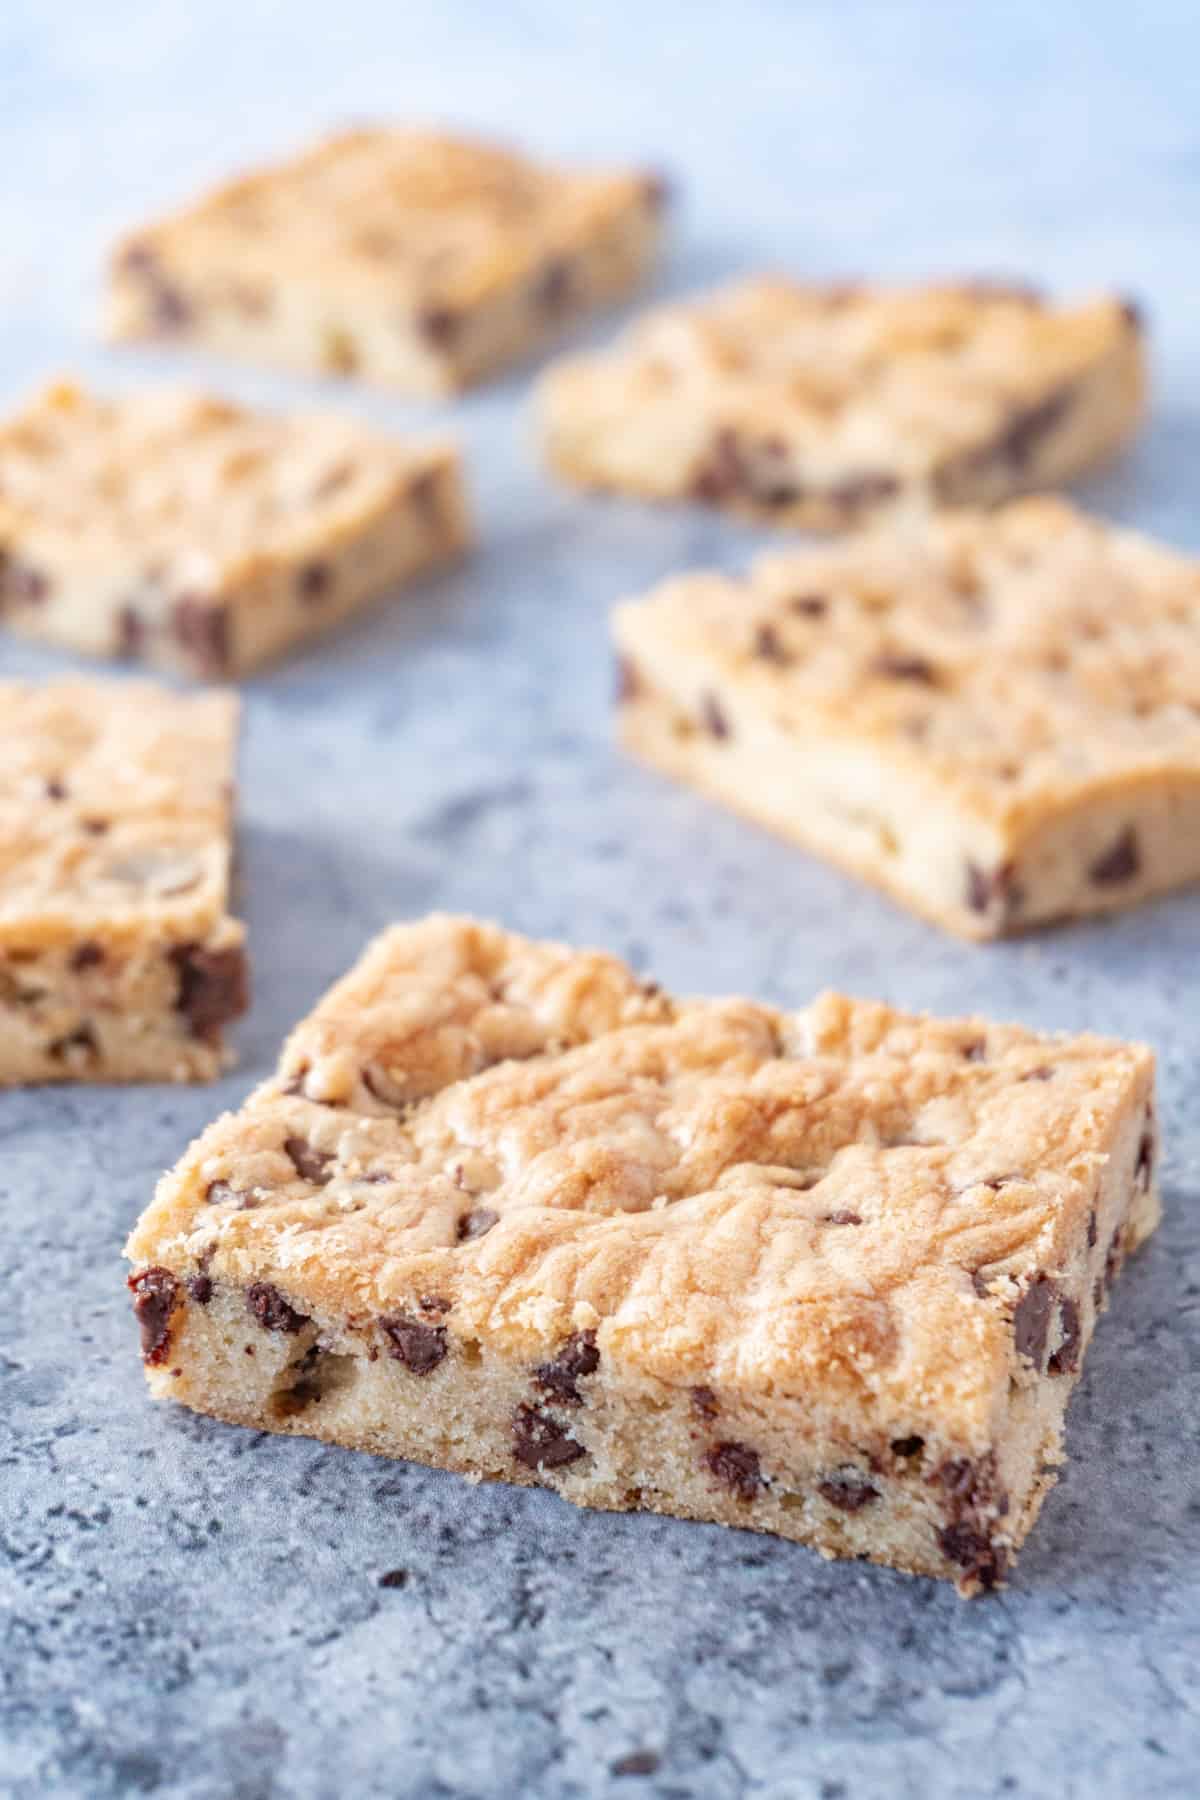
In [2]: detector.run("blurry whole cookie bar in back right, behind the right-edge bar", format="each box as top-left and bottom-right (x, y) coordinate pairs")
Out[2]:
(542, 279), (1144, 531)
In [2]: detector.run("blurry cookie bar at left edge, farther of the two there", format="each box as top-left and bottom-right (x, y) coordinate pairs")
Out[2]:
(0, 382), (470, 679)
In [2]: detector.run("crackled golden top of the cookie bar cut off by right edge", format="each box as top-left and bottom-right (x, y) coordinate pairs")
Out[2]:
(615, 499), (1200, 824)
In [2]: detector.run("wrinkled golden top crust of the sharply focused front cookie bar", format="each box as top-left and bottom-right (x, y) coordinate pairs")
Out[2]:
(130, 916), (1151, 1442)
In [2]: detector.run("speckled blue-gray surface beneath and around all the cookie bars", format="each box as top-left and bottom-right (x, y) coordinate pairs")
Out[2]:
(0, 0), (1200, 1800)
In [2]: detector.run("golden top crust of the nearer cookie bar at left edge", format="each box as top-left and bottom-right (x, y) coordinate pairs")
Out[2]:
(0, 680), (237, 950)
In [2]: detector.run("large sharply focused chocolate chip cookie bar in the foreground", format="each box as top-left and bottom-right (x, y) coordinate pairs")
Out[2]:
(128, 918), (1157, 1593)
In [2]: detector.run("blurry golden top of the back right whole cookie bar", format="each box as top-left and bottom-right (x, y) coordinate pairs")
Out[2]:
(549, 277), (1137, 475)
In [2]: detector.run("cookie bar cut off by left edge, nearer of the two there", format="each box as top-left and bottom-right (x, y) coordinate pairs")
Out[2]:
(0, 680), (246, 1087)
